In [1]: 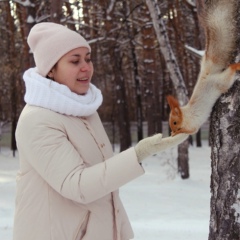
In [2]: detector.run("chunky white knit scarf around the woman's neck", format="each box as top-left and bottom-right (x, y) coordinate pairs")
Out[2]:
(23, 68), (103, 117)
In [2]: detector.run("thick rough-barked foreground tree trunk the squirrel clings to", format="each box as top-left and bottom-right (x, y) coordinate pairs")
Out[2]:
(208, 81), (240, 240)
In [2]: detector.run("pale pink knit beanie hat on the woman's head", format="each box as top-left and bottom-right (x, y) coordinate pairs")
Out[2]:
(27, 22), (91, 77)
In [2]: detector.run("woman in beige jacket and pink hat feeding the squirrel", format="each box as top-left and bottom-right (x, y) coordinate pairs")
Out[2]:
(14, 23), (187, 240)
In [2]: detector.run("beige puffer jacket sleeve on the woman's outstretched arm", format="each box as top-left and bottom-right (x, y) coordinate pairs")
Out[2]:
(16, 107), (144, 204)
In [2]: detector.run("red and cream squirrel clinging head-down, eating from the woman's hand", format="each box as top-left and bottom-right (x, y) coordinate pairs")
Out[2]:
(167, 0), (240, 136)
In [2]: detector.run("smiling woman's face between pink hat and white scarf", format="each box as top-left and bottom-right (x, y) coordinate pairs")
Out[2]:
(48, 47), (93, 95)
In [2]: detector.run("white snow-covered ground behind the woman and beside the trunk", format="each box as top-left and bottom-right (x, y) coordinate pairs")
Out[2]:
(0, 142), (211, 240)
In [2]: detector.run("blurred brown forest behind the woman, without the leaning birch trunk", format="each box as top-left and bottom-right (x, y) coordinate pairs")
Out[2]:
(0, 0), (204, 153)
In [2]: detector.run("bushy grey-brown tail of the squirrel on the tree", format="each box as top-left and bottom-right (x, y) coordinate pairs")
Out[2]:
(198, 0), (239, 69)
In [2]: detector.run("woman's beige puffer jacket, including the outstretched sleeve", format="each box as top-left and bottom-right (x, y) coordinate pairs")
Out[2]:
(13, 105), (144, 240)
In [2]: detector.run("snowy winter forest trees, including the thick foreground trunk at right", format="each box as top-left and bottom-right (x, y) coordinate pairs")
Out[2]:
(0, 0), (240, 240)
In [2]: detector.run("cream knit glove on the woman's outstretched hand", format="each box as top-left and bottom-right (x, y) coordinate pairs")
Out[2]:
(135, 133), (189, 162)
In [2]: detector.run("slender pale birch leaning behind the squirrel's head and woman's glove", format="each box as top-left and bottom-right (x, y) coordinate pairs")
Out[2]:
(146, 0), (189, 178)
